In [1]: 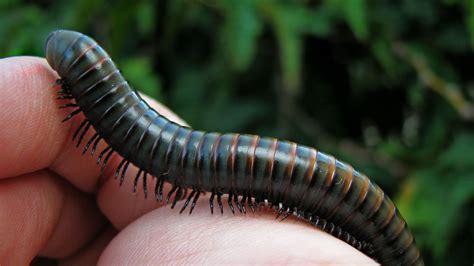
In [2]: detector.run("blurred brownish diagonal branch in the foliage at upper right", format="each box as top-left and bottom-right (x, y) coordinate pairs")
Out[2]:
(392, 42), (474, 121)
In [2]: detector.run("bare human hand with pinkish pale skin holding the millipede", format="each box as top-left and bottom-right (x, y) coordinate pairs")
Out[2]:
(0, 57), (374, 265)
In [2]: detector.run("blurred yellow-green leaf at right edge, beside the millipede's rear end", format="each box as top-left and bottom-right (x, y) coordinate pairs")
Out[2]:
(397, 133), (474, 258)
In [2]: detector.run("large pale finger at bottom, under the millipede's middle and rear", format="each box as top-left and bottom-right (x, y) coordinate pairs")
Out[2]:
(99, 201), (374, 265)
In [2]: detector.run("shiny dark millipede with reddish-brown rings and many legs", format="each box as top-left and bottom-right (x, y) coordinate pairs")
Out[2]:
(45, 30), (423, 265)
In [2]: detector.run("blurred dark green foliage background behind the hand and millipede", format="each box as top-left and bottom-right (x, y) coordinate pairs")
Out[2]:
(0, 0), (474, 265)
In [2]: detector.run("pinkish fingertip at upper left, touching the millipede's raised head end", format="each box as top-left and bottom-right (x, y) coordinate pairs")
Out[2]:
(0, 57), (68, 178)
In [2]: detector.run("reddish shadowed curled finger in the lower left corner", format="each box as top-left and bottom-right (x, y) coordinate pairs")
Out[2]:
(0, 171), (104, 265)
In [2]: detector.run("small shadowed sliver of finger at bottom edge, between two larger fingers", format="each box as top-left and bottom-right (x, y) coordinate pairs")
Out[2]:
(59, 227), (117, 266)
